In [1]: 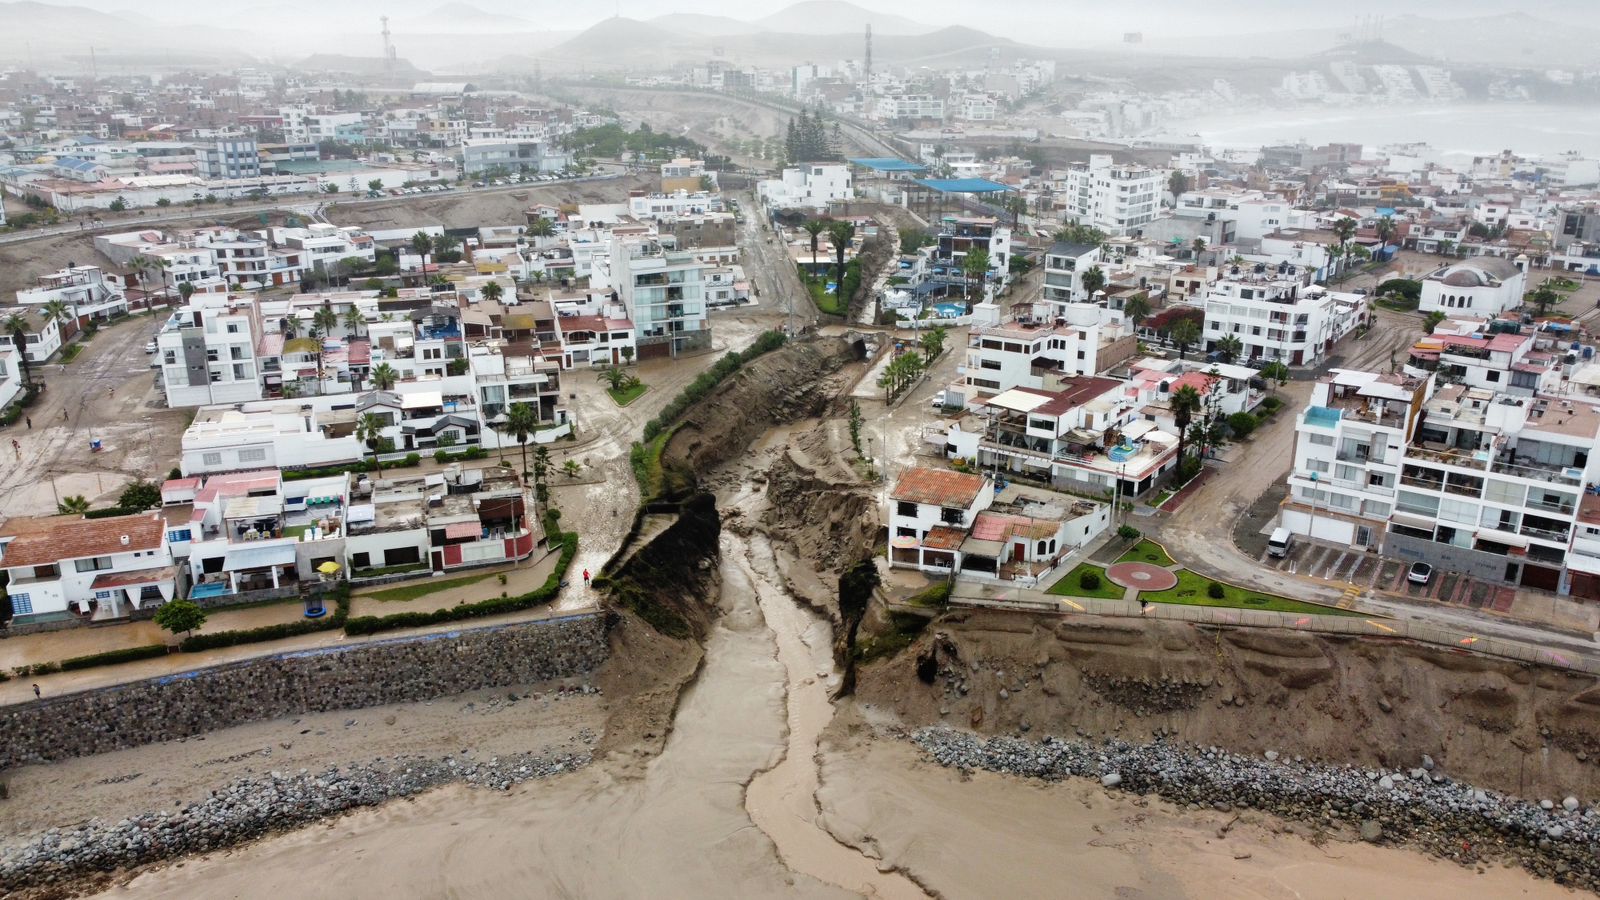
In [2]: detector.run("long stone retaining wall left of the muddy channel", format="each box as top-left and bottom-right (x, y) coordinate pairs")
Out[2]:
(0, 613), (606, 769)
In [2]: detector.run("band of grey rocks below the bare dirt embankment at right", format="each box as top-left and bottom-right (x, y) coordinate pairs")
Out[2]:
(910, 727), (1600, 890)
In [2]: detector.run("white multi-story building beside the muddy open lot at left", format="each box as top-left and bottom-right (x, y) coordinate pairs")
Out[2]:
(155, 293), (262, 407)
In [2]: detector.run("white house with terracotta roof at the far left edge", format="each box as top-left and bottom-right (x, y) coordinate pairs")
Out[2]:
(0, 512), (178, 625)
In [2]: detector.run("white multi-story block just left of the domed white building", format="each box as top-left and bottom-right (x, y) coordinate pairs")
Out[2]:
(1200, 266), (1368, 365)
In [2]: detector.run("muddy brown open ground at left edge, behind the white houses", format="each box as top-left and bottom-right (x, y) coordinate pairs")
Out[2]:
(0, 315), (189, 516)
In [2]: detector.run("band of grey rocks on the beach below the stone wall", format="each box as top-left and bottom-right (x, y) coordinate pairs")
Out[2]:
(0, 751), (590, 895)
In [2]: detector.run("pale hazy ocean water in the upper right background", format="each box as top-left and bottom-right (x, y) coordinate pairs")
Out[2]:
(1165, 102), (1600, 160)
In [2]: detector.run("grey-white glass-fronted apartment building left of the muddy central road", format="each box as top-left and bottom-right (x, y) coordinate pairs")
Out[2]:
(595, 237), (710, 359)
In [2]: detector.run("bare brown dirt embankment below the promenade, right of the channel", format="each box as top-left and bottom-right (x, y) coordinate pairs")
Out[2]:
(858, 612), (1600, 798)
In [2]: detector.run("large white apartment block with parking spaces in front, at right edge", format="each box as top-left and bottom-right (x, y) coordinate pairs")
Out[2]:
(1282, 370), (1600, 596)
